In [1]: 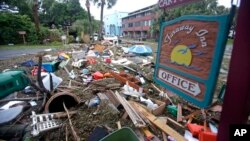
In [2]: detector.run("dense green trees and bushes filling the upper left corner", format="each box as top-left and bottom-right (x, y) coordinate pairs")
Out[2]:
(0, 0), (99, 44)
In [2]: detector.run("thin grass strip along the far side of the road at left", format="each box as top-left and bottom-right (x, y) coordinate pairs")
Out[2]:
(0, 44), (64, 50)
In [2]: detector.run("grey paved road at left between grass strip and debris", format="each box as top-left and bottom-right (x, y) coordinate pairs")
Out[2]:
(0, 48), (49, 60)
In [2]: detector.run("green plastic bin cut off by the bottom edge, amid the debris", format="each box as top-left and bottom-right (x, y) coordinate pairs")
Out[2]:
(100, 127), (139, 141)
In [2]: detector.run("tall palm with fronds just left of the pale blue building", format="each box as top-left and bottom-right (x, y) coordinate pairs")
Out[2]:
(91, 0), (117, 38)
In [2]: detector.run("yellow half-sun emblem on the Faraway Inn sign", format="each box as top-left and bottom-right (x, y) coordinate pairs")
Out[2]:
(171, 45), (192, 66)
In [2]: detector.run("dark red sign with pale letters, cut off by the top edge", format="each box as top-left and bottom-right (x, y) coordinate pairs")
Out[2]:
(158, 0), (200, 9)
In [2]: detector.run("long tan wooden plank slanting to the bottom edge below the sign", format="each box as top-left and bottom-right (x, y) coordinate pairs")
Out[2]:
(133, 102), (187, 141)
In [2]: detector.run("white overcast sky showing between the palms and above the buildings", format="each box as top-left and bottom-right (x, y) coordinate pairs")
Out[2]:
(80, 0), (236, 20)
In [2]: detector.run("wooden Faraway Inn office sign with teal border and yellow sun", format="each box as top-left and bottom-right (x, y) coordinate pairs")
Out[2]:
(154, 15), (229, 108)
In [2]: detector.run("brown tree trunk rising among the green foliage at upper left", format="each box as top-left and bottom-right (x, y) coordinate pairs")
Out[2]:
(27, 0), (40, 34)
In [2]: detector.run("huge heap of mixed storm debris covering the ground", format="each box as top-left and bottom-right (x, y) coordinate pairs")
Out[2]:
(0, 42), (230, 141)
